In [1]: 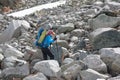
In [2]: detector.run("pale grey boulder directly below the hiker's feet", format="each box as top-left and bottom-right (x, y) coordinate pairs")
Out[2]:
(33, 60), (61, 77)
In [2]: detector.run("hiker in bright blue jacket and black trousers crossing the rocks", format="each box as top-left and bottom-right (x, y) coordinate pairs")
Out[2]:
(35, 28), (57, 60)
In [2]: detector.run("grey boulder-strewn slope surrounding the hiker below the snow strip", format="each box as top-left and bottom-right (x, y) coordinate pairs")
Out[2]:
(0, 0), (120, 80)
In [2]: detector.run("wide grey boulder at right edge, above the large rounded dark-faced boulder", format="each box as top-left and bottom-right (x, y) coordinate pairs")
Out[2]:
(89, 14), (120, 30)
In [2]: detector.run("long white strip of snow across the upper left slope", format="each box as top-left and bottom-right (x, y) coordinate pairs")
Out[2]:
(7, 0), (66, 17)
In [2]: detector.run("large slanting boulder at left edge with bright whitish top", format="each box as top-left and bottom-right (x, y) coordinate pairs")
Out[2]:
(0, 20), (30, 43)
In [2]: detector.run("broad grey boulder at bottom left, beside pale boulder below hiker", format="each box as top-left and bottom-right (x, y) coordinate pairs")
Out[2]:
(2, 63), (30, 80)
